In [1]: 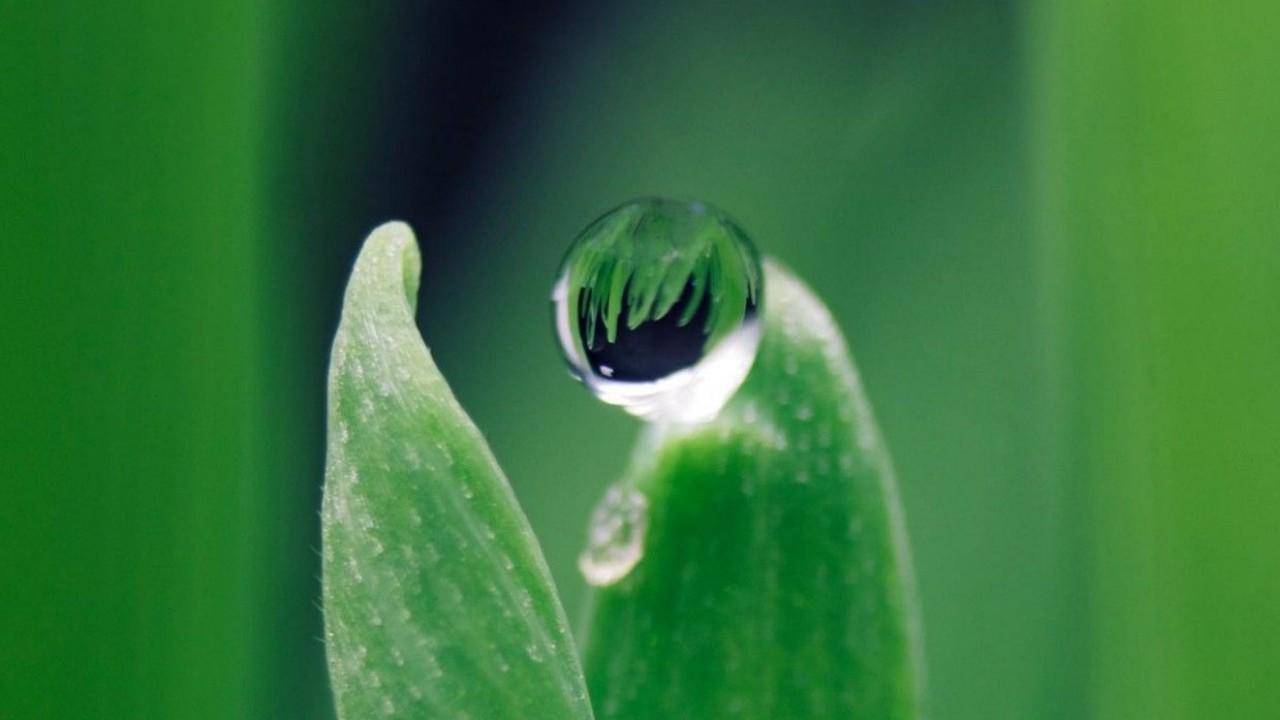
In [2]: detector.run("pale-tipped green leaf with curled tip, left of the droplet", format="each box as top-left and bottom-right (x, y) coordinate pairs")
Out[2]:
(323, 223), (591, 720)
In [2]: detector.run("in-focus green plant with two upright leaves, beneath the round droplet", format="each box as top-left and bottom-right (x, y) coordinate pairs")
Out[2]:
(323, 204), (923, 720)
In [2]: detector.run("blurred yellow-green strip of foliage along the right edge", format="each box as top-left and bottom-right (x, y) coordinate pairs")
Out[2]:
(1032, 0), (1280, 719)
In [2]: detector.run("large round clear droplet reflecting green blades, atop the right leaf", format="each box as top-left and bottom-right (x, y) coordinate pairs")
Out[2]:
(552, 199), (763, 423)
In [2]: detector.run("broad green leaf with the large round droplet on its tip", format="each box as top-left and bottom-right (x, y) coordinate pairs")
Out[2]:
(582, 263), (923, 720)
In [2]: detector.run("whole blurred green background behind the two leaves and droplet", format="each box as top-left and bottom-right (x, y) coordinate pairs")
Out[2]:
(0, 0), (1280, 720)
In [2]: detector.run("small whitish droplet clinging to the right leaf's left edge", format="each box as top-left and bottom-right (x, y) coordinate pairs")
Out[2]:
(577, 487), (649, 585)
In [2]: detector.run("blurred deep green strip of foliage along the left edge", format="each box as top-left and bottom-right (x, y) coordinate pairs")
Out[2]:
(0, 1), (276, 719)
